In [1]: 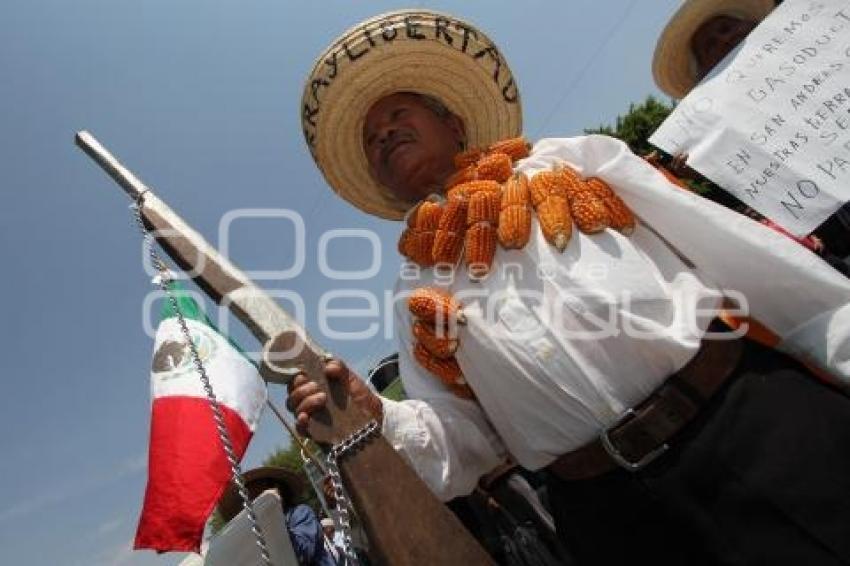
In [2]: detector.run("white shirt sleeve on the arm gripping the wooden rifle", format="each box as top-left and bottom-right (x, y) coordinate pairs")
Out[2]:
(382, 280), (506, 501)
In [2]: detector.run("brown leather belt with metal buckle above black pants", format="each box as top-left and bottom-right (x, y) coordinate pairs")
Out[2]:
(549, 330), (743, 480)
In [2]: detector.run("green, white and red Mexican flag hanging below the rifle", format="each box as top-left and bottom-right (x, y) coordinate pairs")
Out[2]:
(134, 282), (266, 552)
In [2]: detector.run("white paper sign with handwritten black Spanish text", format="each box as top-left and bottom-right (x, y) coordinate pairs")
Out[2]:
(650, 0), (850, 236)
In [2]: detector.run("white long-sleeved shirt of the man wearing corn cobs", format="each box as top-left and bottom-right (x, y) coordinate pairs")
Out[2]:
(383, 136), (850, 499)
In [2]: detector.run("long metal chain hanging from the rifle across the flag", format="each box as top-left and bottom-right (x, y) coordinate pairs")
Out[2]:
(130, 202), (272, 566)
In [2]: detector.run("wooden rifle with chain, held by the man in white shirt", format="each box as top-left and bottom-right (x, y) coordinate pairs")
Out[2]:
(76, 131), (493, 566)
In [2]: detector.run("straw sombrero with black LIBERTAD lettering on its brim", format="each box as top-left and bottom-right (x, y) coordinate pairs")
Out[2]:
(301, 9), (522, 220)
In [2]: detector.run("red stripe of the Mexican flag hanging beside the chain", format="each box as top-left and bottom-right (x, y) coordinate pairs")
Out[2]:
(134, 396), (251, 552)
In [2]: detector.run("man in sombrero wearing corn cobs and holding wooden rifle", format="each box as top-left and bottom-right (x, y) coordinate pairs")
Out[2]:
(288, 10), (850, 565)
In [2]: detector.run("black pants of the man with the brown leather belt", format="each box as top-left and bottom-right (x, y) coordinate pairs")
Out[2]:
(549, 342), (850, 566)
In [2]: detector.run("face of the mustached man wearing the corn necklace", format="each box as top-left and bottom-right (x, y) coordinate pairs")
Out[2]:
(363, 93), (464, 202)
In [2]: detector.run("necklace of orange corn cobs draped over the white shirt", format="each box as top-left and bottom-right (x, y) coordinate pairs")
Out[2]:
(398, 137), (635, 398)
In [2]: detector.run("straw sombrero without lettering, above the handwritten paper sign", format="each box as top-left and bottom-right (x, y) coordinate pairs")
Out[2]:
(652, 0), (775, 99)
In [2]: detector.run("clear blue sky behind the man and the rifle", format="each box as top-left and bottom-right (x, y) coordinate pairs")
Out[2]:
(0, 0), (679, 565)
